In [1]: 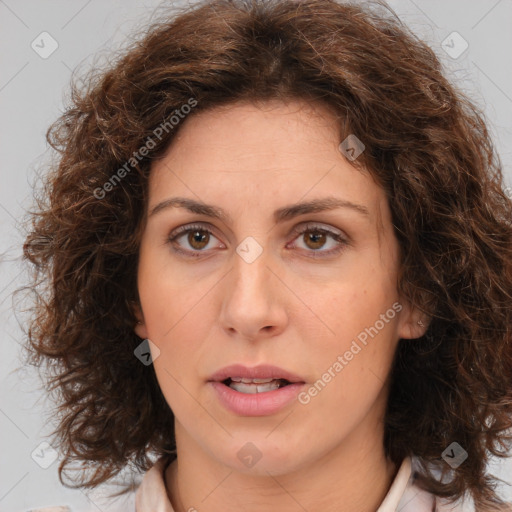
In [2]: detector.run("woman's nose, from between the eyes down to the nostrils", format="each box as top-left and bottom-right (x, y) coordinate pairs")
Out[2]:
(220, 249), (290, 341)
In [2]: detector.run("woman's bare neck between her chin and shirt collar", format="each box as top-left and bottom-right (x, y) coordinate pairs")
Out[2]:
(165, 406), (398, 512)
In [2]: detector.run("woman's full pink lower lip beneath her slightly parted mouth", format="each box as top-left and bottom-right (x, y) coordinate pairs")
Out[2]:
(210, 382), (305, 416)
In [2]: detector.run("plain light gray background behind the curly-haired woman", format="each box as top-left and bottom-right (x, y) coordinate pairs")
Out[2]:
(0, 0), (512, 512)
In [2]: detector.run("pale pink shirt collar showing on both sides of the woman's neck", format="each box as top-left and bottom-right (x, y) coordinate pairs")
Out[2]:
(135, 457), (467, 512)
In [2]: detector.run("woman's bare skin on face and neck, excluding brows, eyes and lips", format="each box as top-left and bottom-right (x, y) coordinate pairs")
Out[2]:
(136, 100), (428, 512)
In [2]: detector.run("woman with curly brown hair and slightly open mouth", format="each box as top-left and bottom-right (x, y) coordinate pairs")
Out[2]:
(25, 0), (512, 512)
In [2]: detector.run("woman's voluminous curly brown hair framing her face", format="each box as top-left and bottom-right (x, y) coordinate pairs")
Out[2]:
(24, 0), (512, 511)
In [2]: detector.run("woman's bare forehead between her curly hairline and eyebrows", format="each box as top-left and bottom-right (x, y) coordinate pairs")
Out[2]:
(148, 101), (387, 234)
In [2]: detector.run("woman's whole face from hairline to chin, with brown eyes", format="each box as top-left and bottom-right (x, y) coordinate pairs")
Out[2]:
(136, 101), (426, 474)
